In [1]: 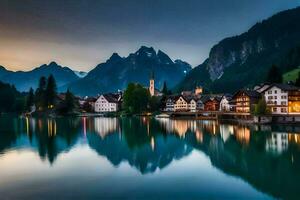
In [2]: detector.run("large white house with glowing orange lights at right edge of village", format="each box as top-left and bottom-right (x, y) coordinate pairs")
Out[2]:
(264, 84), (300, 114)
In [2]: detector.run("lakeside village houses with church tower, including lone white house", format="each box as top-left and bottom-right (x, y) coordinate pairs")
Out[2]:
(79, 73), (300, 123)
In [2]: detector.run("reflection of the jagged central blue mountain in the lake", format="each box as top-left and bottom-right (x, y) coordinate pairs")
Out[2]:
(87, 119), (192, 174)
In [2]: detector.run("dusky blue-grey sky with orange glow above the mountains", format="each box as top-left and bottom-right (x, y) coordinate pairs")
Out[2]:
(0, 0), (300, 71)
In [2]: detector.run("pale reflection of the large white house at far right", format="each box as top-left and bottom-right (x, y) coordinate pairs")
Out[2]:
(266, 132), (288, 153)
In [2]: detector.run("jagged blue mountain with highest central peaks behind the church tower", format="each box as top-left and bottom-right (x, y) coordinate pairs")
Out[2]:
(65, 46), (191, 95)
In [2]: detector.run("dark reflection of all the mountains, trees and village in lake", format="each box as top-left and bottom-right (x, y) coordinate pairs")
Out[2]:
(0, 117), (300, 198)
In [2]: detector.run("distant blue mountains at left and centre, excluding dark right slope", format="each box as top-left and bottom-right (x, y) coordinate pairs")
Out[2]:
(0, 46), (192, 96)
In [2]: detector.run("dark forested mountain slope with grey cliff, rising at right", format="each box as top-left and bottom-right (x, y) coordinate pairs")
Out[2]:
(176, 7), (300, 92)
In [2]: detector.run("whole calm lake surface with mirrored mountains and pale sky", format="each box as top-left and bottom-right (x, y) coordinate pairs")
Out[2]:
(0, 116), (300, 199)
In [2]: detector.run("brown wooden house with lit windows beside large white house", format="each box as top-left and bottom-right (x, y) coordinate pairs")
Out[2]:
(232, 90), (260, 113)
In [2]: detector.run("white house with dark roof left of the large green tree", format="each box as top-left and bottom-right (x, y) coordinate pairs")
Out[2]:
(95, 93), (122, 112)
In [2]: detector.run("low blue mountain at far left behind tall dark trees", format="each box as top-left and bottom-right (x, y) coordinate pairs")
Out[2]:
(0, 62), (79, 91)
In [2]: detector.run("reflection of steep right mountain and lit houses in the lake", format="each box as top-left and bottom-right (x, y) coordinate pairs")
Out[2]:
(158, 119), (300, 199)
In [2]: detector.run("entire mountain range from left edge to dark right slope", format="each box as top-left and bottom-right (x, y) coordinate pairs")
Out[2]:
(0, 7), (300, 96)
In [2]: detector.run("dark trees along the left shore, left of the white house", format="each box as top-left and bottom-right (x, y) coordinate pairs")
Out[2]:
(0, 75), (78, 114)
